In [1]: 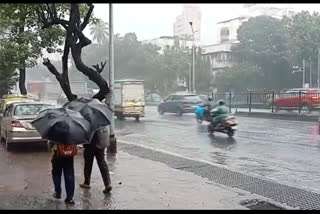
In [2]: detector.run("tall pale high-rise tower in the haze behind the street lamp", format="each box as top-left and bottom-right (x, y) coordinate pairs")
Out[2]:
(173, 4), (201, 46)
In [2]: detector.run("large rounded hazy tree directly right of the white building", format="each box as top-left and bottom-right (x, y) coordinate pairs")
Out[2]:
(233, 16), (292, 89)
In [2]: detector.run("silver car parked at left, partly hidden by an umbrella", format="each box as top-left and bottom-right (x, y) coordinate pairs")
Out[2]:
(0, 102), (54, 150)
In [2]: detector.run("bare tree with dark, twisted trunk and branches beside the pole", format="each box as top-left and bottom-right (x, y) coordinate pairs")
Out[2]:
(36, 3), (110, 101)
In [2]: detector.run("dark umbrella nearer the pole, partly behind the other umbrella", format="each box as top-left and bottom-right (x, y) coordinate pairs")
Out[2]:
(63, 98), (113, 131)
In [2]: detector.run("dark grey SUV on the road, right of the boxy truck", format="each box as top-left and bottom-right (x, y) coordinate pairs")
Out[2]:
(158, 93), (203, 116)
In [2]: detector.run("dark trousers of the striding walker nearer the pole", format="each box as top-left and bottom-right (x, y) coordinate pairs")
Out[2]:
(83, 145), (111, 187)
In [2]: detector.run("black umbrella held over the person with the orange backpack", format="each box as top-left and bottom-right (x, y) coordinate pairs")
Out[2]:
(31, 108), (93, 145)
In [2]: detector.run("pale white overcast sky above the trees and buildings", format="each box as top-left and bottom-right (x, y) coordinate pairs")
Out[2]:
(86, 4), (320, 45)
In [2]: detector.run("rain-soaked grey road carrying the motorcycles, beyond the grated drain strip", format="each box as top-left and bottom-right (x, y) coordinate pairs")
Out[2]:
(116, 107), (320, 192)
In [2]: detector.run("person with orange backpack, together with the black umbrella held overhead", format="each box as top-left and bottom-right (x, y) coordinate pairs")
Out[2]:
(31, 108), (93, 204)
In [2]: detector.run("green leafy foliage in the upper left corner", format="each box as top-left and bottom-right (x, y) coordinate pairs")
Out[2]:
(0, 4), (65, 67)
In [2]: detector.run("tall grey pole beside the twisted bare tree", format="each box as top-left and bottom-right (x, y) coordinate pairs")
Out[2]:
(106, 3), (117, 153)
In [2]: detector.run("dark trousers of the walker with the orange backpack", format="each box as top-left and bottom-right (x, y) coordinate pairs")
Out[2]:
(51, 156), (75, 199)
